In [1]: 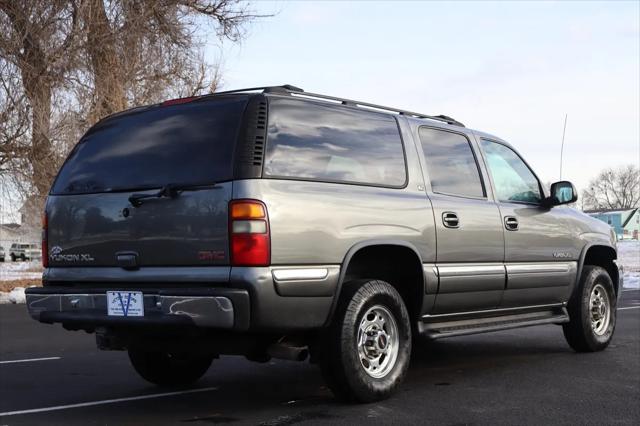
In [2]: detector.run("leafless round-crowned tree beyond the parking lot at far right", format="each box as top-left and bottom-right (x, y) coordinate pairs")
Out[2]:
(582, 164), (640, 210)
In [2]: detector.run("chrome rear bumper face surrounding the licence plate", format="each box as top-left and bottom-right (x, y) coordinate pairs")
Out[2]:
(25, 287), (249, 330)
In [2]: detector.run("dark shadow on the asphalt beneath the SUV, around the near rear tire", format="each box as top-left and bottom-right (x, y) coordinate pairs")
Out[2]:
(158, 333), (572, 424)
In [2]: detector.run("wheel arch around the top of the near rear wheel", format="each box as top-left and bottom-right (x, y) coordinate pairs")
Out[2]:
(325, 239), (425, 326)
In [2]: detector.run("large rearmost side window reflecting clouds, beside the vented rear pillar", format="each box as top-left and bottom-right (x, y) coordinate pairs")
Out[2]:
(264, 99), (406, 186)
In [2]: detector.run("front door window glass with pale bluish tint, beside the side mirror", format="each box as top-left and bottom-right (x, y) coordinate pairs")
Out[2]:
(481, 139), (542, 204)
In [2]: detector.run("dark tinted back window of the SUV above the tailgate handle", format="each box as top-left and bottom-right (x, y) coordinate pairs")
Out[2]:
(52, 98), (246, 194)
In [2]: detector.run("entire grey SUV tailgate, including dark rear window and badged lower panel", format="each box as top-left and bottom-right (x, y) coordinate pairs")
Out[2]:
(47, 97), (246, 269)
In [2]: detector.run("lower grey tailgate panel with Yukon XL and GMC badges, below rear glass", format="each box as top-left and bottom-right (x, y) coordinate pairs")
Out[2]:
(47, 182), (232, 267)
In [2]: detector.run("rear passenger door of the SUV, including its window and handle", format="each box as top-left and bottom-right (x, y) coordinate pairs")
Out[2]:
(418, 126), (505, 314)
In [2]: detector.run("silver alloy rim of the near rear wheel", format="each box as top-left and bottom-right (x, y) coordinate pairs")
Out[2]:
(357, 305), (399, 379)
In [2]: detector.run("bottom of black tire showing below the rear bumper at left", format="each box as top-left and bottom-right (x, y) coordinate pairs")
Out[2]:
(129, 348), (213, 386)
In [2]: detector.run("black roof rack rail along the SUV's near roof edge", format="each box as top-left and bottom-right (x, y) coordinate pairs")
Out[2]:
(213, 84), (465, 127)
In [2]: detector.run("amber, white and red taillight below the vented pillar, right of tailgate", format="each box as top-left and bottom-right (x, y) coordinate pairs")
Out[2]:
(229, 200), (271, 266)
